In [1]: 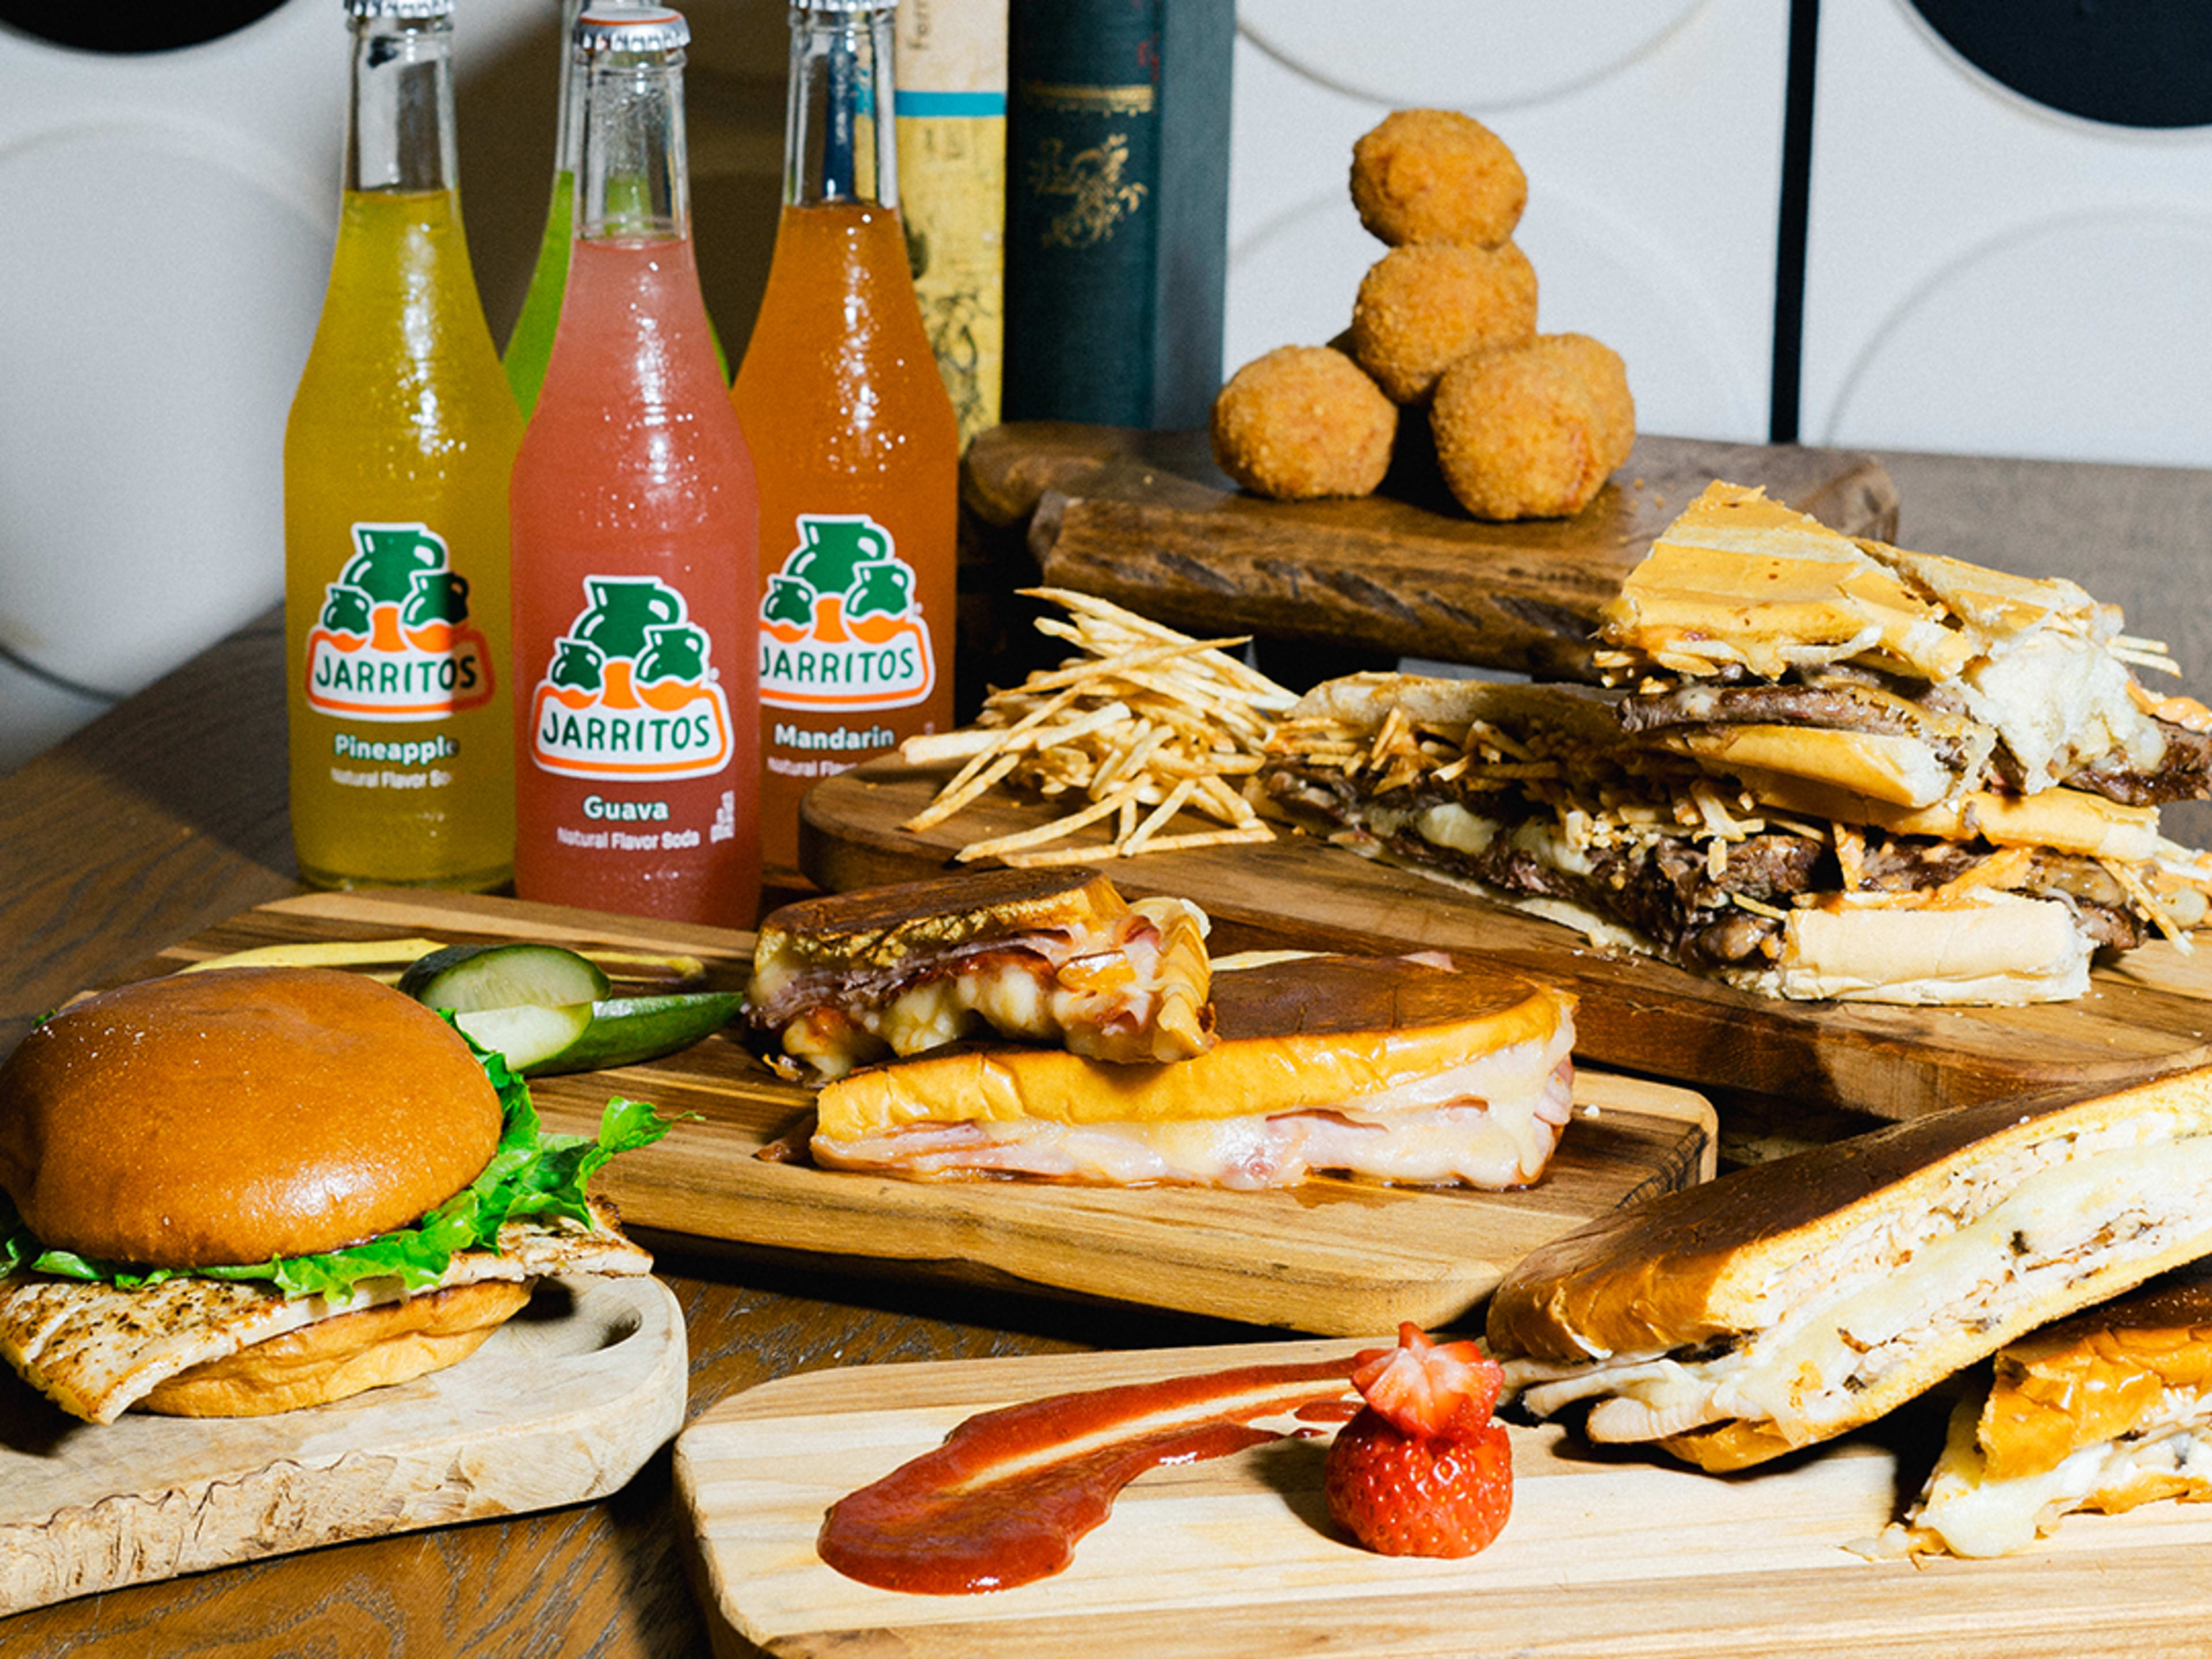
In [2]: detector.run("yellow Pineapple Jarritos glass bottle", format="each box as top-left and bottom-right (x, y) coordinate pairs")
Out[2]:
(283, 0), (522, 889)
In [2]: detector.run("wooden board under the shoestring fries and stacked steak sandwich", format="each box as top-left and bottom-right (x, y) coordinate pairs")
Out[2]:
(801, 761), (2212, 1119)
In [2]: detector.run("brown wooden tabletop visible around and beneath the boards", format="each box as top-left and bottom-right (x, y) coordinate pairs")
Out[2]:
(13, 444), (2212, 1659)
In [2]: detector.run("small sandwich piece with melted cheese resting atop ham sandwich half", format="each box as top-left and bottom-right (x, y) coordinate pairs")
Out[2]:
(750, 869), (1212, 1080)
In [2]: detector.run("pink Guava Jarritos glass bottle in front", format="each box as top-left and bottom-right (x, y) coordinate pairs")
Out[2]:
(511, 7), (761, 927)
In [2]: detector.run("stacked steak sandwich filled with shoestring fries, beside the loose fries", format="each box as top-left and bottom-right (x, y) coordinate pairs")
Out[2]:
(1254, 484), (2212, 1002)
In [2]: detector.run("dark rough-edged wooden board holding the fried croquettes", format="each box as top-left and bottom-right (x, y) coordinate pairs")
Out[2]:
(960, 435), (1898, 679)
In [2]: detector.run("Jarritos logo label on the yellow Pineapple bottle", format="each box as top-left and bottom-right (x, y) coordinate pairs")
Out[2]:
(308, 524), (493, 721)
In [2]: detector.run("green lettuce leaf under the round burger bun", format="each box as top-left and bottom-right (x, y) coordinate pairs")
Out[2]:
(0, 1042), (677, 1296)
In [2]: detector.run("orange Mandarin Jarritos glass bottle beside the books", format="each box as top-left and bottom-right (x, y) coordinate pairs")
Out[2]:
(730, 0), (960, 876)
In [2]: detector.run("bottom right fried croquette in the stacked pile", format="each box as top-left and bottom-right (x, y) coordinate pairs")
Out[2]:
(1429, 345), (1612, 520)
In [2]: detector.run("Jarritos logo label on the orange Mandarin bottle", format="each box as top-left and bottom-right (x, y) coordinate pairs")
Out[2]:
(761, 513), (938, 714)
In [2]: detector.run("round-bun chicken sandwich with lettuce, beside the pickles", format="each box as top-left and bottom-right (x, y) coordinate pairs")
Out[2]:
(0, 967), (666, 1422)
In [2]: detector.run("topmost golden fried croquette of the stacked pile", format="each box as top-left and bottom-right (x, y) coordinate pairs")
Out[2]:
(1351, 108), (1528, 248)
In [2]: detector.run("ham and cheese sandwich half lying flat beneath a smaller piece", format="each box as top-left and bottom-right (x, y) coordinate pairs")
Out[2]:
(812, 956), (1575, 1190)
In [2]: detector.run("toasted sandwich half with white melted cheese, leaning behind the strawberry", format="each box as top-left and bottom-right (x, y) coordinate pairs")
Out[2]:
(1488, 1069), (2212, 1469)
